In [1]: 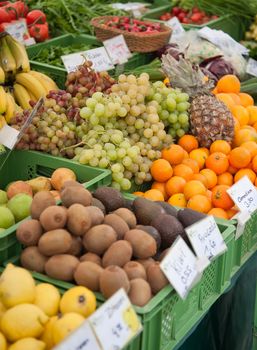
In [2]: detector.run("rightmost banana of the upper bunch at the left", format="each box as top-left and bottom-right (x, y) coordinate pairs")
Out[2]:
(5, 35), (30, 72)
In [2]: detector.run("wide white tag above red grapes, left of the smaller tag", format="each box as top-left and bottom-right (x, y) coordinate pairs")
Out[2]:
(61, 47), (114, 73)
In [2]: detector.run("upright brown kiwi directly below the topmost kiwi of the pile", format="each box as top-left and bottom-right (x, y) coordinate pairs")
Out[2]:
(67, 204), (92, 236)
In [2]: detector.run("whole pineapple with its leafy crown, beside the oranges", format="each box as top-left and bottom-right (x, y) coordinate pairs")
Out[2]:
(162, 54), (234, 147)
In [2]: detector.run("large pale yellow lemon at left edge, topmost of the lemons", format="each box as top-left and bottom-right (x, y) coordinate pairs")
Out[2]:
(0, 264), (36, 308)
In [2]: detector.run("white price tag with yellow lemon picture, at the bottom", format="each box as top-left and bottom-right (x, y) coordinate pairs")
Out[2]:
(89, 289), (142, 350)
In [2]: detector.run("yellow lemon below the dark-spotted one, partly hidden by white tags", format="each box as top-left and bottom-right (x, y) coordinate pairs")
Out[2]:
(52, 312), (85, 345)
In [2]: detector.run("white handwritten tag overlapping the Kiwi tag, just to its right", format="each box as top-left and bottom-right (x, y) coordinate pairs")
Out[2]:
(185, 216), (228, 260)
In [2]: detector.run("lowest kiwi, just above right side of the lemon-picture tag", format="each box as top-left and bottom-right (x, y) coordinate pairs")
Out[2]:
(128, 278), (152, 307)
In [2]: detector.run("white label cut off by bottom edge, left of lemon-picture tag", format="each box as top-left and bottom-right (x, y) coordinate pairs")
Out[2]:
(54, 321), (101, 350)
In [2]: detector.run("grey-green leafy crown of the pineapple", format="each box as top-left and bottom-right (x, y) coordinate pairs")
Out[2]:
(161, 54), (214, 97)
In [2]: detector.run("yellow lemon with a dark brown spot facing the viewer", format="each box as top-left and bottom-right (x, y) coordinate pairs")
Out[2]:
(60, 286), (96, 317)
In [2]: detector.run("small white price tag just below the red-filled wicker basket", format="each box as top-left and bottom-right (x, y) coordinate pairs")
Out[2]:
(103, 35), (132, 64)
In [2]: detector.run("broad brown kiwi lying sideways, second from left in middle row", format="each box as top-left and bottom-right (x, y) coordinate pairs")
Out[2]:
(38, 229), (72, 256)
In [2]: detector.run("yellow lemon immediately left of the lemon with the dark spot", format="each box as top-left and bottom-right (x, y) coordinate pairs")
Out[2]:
(34, 283), (61, 316)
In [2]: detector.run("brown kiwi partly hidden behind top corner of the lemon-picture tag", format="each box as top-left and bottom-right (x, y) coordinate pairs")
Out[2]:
(100, 265), (130, 299)
